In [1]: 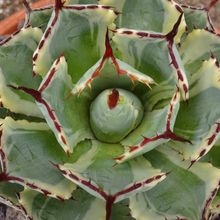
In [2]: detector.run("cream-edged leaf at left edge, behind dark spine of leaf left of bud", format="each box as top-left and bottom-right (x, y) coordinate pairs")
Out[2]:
(0, 27), (42, 117)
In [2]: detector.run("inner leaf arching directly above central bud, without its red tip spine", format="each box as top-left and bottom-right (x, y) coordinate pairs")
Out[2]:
(71, 58), (154, 99)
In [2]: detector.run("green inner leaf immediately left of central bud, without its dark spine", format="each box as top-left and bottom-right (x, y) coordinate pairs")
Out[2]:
(38, 57), (93, 152)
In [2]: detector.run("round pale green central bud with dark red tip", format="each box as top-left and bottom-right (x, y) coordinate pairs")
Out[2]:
(90, 89), (144, 143)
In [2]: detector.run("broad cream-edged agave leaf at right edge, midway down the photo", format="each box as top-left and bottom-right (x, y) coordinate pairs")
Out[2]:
(172, 58), (220, 164)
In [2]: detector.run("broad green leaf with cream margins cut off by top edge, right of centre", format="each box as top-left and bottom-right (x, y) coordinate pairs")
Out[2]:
(99, 0), (185, 41)
